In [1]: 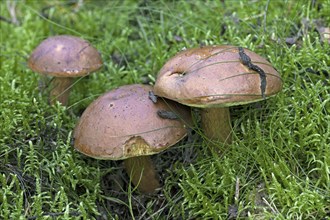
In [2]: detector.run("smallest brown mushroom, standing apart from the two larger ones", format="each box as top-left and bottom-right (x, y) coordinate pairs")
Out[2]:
(28, 35), (102, 105)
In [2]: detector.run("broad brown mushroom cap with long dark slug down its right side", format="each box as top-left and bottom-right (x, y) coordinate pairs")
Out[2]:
(154, 46), (282, 107)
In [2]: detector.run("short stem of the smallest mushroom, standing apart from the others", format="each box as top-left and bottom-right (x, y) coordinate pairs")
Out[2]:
(49, 77), (73, 106)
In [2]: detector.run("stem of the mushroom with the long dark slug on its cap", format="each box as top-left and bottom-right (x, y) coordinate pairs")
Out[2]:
(201, 107), (232, 147)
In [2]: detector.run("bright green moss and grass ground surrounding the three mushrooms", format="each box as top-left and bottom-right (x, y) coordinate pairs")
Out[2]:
(0, 0), (330, 219)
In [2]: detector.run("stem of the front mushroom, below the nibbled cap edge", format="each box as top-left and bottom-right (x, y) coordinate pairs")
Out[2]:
(124, 156), (160, 193)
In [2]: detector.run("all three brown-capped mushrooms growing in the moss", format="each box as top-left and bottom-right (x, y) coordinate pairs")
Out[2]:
(28, 35), (282, 193)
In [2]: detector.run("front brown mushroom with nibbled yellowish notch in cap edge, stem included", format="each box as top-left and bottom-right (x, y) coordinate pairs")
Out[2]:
(74, 84), (191, 193)
